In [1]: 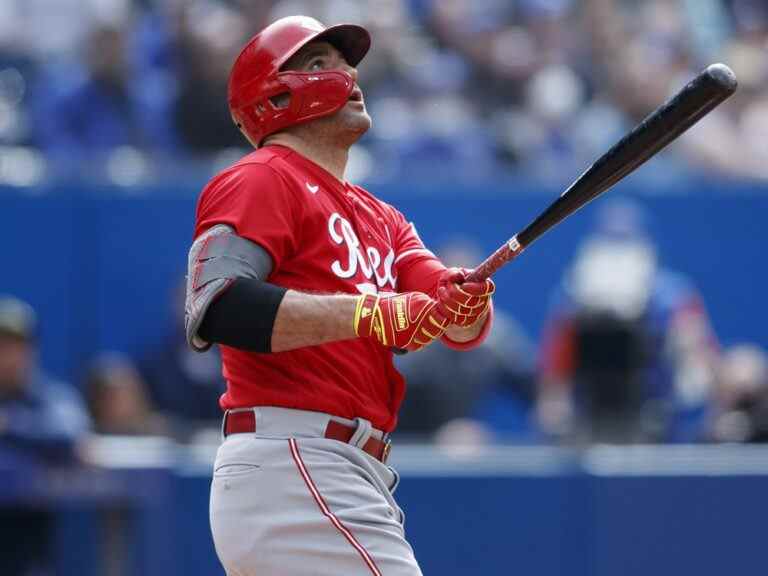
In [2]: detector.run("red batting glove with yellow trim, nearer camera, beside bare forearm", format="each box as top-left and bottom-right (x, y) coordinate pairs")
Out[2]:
(353, 292), (448, 352)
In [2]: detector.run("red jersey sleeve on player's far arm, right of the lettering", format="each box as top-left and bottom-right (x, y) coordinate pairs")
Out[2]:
(392, 208), (445, 295)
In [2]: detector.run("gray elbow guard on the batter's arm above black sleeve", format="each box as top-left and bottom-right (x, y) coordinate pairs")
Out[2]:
(184, 224), (272, 352)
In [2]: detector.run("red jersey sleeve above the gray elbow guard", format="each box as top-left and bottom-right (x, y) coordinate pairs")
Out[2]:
(195, 164), (302, 268)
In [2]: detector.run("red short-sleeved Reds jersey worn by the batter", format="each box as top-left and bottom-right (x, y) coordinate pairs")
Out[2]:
(195, 146), (436, 431)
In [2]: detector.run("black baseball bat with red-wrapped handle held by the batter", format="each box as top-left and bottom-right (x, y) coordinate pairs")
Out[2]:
(467, 64), (738, 282)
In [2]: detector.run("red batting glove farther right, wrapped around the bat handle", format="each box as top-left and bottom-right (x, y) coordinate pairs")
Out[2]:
(437, 268), (496, 326)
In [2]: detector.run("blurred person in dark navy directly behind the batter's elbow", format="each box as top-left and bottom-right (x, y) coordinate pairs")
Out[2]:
(138, 284), (224, 435)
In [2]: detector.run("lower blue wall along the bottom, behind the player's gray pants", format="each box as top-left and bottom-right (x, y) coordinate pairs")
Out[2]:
(46, 454), (768, 576)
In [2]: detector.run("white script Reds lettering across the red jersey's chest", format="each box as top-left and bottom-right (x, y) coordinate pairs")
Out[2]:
(328, 212), (395, 289)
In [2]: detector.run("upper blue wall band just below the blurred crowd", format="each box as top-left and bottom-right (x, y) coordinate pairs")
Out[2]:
(0, 182), (768, 379)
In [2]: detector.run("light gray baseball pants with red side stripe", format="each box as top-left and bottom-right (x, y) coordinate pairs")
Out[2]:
(210, 408), (421, 576)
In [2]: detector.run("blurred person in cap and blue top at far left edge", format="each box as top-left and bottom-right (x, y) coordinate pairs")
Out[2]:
(0, 296), (89, 460)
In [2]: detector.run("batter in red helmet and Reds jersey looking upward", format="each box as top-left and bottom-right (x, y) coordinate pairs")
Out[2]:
(186, 16), (494, 576)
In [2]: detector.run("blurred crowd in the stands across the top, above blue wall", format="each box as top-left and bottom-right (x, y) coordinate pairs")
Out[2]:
(0, 0), (768, 185)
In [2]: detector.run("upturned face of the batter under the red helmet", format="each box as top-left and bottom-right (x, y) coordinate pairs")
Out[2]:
(283, 42), (371, 139)
